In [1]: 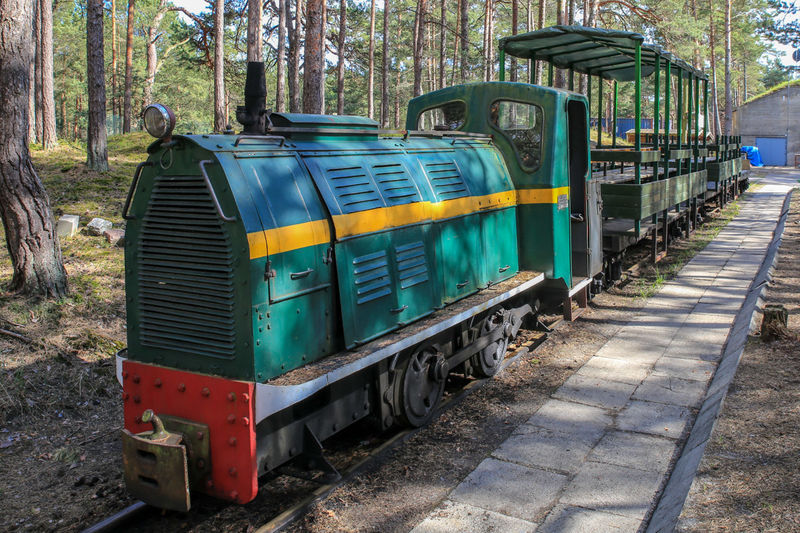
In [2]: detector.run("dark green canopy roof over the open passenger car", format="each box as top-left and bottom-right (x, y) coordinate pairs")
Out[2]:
(500, 26), (706, 81)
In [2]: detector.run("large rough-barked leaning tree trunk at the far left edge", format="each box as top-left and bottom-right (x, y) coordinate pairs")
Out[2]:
(0, 0), (67, 298)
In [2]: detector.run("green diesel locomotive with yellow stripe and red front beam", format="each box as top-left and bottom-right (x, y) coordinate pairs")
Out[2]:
(118, 27), (744, 510)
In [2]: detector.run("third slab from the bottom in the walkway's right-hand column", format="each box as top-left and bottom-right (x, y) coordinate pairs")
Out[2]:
(589, 431), (675, 474)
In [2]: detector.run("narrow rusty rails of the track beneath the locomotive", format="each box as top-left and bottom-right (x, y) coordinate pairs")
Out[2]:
(82, 328), (563, 533)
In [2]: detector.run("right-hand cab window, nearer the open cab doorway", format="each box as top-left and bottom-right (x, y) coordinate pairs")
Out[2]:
(489, 100), (544, 171)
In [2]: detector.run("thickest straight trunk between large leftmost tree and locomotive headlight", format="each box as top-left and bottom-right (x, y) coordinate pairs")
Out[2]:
(87, 0), (108, 172)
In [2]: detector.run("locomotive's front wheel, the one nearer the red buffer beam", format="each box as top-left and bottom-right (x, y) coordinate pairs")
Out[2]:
(395, 348), (450, 427)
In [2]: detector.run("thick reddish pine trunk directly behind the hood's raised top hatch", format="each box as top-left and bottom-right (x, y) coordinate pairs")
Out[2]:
(303, 0), (325, 114)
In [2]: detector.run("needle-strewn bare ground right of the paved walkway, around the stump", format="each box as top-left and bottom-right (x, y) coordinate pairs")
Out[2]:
(678, 192), (800, 532)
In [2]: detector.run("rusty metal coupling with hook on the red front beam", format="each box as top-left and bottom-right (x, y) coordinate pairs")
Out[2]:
(122, 409), (211, 512)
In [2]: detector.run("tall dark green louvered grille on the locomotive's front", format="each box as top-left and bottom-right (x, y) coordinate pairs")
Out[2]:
(139, 176), (236, 357)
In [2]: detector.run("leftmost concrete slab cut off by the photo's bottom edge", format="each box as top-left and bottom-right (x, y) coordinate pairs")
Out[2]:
(411, 500), (536, 533)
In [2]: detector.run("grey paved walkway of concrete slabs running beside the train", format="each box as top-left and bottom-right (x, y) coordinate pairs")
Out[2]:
(413, 175), (800, 533)
